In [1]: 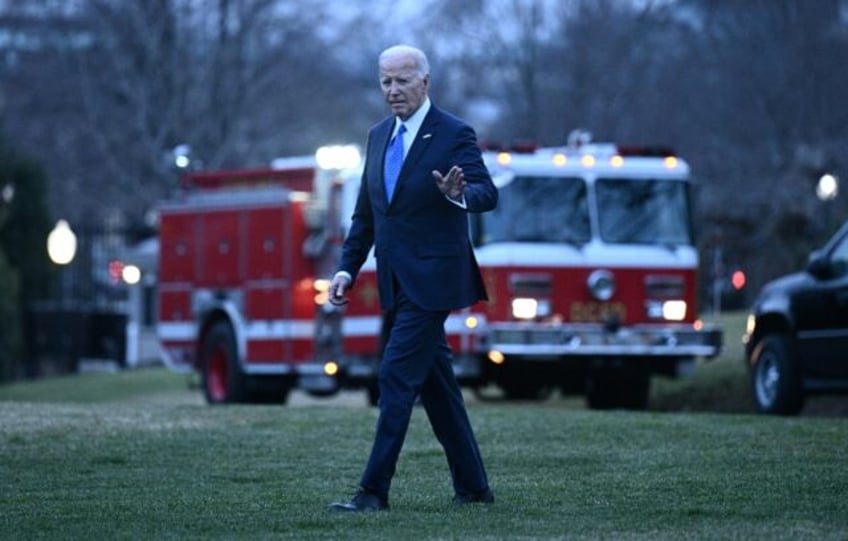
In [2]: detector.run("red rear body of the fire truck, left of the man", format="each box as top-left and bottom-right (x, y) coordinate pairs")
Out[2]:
(157, 147), (359, 403)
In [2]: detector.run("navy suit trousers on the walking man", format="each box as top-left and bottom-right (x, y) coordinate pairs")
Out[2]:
(360, 288), (489, 498)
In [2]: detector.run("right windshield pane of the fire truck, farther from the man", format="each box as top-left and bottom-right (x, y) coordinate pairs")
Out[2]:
(595, 178), (693, 246)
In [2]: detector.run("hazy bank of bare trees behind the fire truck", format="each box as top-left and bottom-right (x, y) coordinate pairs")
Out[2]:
(0, 0), (848, 296)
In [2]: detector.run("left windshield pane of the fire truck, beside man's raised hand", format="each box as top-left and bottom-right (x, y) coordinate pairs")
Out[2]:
(473, 176), (591, 245)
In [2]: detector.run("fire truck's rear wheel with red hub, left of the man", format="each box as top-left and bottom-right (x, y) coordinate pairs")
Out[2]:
(200, 321), (246, 404)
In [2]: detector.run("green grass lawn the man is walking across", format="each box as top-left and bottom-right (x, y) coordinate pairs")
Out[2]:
(0, 312), (848, 540)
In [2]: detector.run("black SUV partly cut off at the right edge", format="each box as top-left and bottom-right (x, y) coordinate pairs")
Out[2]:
(743, 222), (848, 415)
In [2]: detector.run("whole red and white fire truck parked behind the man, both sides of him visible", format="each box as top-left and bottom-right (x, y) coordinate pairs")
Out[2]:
(159, 133), (722, 409)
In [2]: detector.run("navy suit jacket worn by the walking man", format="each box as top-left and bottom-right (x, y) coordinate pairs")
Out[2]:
(340, 105), (498, 311)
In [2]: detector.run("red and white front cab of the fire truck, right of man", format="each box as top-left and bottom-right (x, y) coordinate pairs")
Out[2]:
(464, 134), (722, 409)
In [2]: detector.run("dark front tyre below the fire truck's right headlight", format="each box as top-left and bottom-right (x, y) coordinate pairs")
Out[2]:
(586, 364), (651, 410)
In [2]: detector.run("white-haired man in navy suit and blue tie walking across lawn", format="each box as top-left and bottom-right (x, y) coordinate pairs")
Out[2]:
(330, 45), (498, 511)
